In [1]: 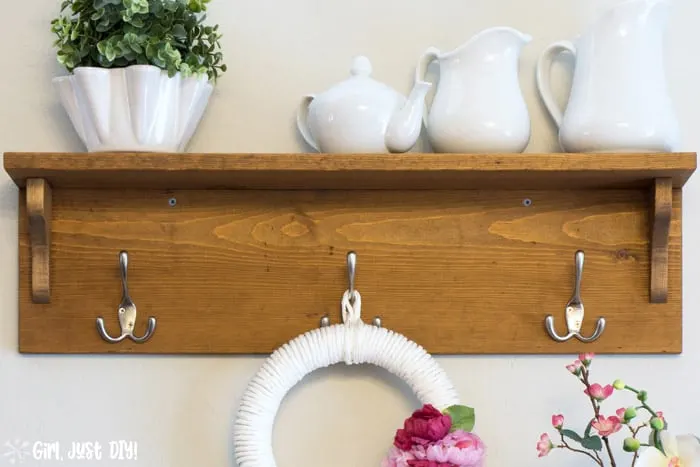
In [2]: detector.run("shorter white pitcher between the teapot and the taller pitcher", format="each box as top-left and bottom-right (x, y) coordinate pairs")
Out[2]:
(417, 27), (532, 153)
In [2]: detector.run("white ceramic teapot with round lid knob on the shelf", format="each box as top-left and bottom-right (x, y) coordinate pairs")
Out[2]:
(297, 56), (431, 153)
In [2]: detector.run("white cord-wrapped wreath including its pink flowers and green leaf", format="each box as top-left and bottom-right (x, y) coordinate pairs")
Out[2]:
(234, 289), (485, 467)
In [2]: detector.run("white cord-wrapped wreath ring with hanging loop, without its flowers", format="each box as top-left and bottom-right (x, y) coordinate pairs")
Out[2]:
(233, 291), (459, 467)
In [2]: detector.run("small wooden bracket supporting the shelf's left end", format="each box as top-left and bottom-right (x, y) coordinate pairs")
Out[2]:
(27, 178), (51, 303)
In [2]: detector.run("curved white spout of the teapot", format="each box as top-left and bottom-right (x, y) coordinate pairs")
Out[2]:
(384, 80), (432, 153)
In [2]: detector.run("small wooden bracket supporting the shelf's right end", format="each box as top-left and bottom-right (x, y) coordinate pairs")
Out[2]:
(649, 178), (673, 303)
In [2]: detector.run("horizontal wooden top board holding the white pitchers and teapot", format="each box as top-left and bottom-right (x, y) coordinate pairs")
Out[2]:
(4, 153), (696, 190)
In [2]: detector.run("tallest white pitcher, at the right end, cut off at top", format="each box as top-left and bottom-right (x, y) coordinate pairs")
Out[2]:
(537, 0), (680, 152)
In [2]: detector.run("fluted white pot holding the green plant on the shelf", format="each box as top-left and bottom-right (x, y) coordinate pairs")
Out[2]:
(53, 65), (213, 152)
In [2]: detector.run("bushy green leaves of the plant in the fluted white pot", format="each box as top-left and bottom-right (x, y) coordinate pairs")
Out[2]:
(51, 0), (226, 81)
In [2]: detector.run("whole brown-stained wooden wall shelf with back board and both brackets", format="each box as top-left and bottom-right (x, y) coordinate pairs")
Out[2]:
(4, 153), (696, 354)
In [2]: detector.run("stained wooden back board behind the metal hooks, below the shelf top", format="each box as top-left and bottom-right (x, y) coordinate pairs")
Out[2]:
(19, 188), (682, 354)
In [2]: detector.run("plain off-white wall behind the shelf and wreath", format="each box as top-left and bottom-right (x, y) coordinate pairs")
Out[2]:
(0, 0), (700, 467)
